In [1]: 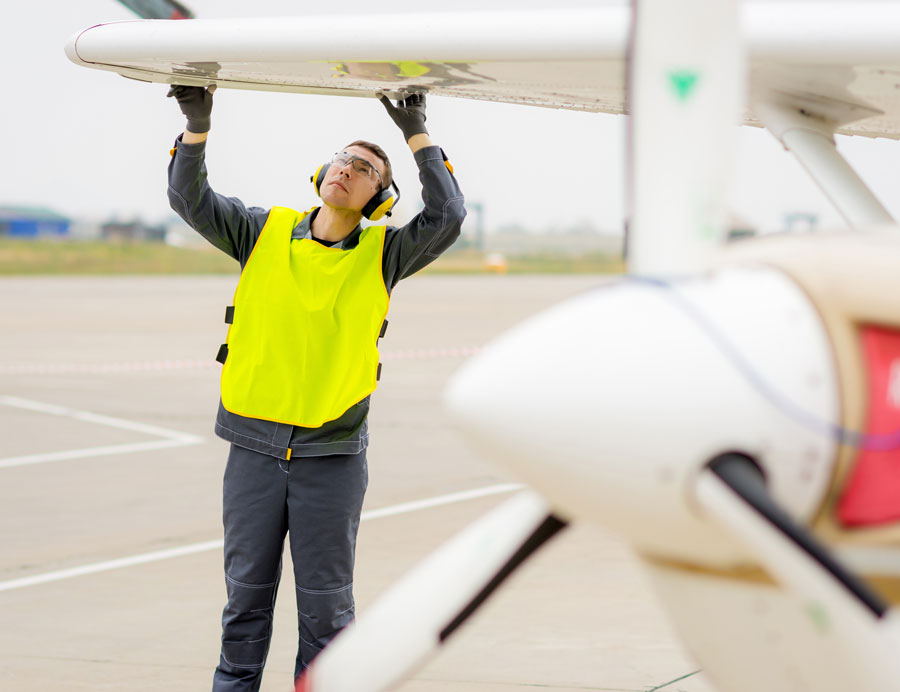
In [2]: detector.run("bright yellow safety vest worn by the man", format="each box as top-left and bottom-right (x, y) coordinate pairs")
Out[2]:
(222, 207), (390, 428)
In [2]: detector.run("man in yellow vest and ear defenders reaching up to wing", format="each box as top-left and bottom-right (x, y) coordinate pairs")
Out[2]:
(169, 86), (465, 691)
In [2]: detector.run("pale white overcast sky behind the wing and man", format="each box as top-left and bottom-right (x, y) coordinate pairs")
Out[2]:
(0, 0), (900, 237)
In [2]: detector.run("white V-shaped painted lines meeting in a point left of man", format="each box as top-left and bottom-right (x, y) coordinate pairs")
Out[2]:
(0, 396), (203, 469)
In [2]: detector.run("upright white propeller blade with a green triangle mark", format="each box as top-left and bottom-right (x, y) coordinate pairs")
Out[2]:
(628, 0), (746, 276)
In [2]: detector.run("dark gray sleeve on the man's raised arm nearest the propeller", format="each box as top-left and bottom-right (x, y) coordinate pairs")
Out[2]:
(382, 146), (466, 288)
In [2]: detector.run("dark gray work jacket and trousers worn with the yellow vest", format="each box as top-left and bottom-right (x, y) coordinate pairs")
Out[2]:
(168, 136), (466, 692)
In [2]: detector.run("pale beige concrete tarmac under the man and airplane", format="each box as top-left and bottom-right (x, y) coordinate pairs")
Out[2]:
(0, 276), (712, 692)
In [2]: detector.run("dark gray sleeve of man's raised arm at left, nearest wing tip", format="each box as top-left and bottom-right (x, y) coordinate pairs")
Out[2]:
(168, 135), (269, 267)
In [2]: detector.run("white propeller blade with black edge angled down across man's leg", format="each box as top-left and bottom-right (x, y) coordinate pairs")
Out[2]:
(296, 491), (566, 692)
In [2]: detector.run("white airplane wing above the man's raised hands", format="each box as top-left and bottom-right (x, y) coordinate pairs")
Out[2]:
(66, 2), (900, 139)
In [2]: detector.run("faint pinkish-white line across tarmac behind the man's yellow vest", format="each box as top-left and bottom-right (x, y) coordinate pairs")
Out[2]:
(0, 346), (482, 375)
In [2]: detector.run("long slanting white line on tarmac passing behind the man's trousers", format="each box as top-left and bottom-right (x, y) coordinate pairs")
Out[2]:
(0, 483), (524, 591)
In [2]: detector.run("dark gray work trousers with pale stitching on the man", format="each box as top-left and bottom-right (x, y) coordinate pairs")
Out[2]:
(213, 445), (369, 692)
